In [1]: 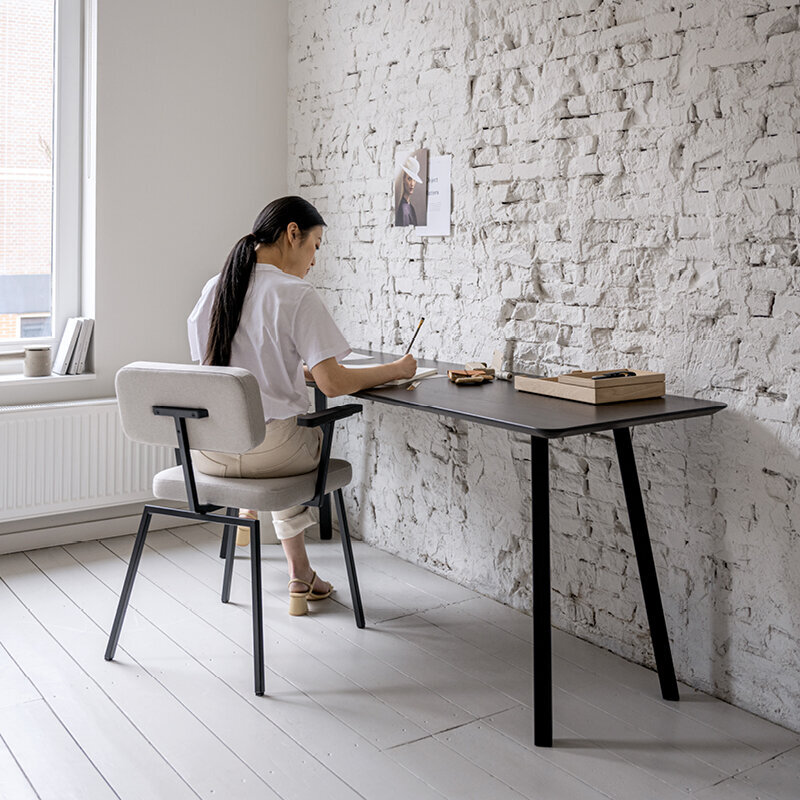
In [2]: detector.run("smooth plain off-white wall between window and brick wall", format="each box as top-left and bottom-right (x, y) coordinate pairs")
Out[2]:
(0, 0), (288, 404)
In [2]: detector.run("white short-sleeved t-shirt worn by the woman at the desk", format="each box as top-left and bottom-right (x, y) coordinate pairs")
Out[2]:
(187, 264), (350, 422)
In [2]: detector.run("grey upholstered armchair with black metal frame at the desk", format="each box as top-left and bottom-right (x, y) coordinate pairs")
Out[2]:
(105, 361), (364, 695)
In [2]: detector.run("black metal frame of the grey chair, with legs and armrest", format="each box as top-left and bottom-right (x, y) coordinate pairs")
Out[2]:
(105, 403), (365, 695)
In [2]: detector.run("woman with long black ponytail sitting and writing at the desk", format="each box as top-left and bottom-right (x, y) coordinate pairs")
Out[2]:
(188, 197), (416, 616)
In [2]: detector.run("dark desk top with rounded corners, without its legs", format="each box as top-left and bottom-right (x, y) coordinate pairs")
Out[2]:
(345, 350), (725, 439)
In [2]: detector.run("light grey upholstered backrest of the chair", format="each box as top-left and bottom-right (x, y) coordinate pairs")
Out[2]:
(116, 361), (266, 453)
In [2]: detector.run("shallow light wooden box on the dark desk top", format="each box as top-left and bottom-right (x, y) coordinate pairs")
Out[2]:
(514, 370), (666, 405)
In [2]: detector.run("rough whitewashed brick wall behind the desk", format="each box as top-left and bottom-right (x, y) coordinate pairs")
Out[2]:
(289, 0), (800, 729)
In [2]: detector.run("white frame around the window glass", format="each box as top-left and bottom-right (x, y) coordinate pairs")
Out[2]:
(0, 0), (85, 354)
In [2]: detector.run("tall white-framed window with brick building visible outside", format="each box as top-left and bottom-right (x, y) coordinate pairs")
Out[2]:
(0, 0), (82, 351)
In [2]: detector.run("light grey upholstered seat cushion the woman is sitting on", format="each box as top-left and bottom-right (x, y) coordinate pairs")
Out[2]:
(153, 458), (353, 511)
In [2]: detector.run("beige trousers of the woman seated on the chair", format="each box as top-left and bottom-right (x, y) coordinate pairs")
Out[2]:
(192, 417), (322, 539)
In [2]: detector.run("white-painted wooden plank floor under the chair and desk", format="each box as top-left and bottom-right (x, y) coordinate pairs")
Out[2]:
(0, 526), (800, 800)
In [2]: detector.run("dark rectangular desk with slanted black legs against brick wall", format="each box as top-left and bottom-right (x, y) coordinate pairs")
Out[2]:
(315, 351), (725, 747)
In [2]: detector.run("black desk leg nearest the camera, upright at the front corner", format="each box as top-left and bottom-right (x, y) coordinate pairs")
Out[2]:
(531, 436), (553, 747)
